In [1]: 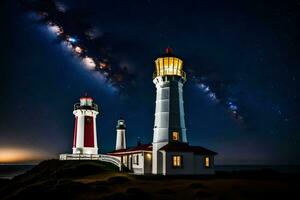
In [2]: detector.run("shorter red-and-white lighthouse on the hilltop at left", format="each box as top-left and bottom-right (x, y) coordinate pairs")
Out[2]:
(73, 95), (99, 154)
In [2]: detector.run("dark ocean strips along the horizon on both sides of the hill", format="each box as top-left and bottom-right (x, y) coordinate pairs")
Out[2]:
(0, 165), (300, 179)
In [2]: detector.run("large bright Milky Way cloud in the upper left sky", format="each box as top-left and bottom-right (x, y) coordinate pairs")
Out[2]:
(19, 0), (135, 92)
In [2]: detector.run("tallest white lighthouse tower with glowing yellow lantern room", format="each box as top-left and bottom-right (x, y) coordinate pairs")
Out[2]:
(152, 48), (187, 174)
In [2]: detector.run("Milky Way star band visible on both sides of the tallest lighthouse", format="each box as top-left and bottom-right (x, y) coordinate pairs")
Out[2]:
(21, 0), (248, 123)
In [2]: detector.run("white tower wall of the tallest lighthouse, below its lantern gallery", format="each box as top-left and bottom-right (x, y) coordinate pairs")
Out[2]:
(152, 76), (187, 174)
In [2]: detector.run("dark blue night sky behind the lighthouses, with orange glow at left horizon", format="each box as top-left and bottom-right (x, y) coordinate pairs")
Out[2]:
(0, 0), (300, 164)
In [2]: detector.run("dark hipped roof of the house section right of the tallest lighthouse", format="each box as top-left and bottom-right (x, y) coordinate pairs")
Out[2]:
(160, 142), (218, 155)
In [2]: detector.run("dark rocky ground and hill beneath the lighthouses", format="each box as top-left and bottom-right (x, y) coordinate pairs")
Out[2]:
(0, 160), (300, 200)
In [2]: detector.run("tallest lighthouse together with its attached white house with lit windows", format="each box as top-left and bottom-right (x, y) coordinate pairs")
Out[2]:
(109, 48), (217, 175)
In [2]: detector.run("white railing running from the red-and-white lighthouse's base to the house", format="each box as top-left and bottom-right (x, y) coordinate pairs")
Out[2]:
(59, 154), (122, 171)
